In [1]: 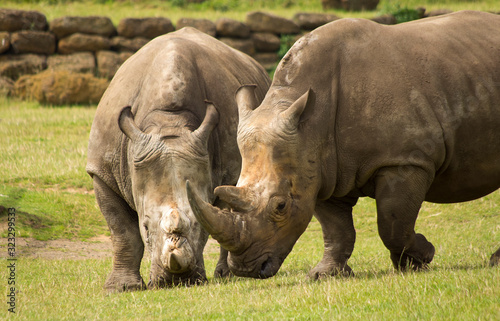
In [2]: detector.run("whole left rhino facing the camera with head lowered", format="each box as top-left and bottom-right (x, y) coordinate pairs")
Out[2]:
(87, 28), (270, 291)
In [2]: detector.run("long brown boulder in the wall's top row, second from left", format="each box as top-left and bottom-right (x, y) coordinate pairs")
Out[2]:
(50, 16), (116, 39)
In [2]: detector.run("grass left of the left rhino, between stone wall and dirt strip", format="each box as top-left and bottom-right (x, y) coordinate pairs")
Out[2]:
(0, 97), (108, 240)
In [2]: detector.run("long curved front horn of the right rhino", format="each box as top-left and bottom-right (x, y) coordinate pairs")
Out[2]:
(186, 181), (246, 252)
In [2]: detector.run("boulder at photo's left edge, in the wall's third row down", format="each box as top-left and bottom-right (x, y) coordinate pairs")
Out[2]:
(0, 54), (47, 80)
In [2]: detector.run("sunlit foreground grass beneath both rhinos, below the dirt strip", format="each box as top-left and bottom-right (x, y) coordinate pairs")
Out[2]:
(0, 191), (500, 320)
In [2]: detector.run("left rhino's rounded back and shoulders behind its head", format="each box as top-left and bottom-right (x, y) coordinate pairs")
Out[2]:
(87, 28), (270, 205)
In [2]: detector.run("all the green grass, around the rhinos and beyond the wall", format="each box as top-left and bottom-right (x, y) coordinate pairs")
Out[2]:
(0, 0), (500, 320)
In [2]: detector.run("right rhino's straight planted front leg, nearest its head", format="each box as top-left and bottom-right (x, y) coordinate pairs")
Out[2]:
(309, 198), (357, 280)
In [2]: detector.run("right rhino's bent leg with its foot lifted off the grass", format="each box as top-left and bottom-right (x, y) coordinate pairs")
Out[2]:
(375, 166), (435, 270)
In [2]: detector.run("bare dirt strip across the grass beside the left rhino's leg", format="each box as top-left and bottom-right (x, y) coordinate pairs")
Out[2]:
(0, 235), (219, 260)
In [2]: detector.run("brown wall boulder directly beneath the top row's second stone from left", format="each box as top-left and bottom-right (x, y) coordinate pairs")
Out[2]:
(57, 33), (111, 54)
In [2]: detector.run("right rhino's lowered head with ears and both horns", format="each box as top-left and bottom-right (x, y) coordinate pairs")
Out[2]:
(186, 86), (320, 278)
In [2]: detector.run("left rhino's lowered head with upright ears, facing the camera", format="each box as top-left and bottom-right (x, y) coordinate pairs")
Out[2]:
(119, 104), (219, 287)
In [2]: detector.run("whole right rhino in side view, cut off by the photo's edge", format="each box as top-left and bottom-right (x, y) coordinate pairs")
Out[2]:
(187, 12), (500, 279)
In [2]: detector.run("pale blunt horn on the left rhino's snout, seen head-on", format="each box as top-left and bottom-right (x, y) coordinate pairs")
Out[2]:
(161, 235), (195, 273)
